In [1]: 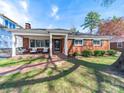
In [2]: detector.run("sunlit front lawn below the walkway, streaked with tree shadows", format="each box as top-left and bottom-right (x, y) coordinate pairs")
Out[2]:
(0, 57), (124, 93)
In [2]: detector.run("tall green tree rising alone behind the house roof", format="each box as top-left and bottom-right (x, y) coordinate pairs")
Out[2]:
(81, 11), (100, 34)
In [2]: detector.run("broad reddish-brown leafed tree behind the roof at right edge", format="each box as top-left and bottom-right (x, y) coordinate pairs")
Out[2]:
(98, 17), (124, 36)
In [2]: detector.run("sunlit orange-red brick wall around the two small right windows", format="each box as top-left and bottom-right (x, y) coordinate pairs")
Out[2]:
(68, 39), (110, 53)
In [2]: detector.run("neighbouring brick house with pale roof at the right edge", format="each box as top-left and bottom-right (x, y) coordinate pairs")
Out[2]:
(110, 36), (124, 51)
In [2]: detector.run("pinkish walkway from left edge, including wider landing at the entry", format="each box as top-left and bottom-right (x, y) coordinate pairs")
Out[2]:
(0, 54), (68, 76)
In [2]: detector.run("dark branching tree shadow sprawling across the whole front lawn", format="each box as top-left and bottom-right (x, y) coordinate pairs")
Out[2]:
(0, 58), (124, 93)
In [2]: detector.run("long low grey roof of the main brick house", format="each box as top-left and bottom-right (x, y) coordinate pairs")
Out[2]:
(6, 28), (110, 40)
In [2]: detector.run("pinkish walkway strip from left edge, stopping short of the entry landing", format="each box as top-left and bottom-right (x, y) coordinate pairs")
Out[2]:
(0, 60), (65, 76)
